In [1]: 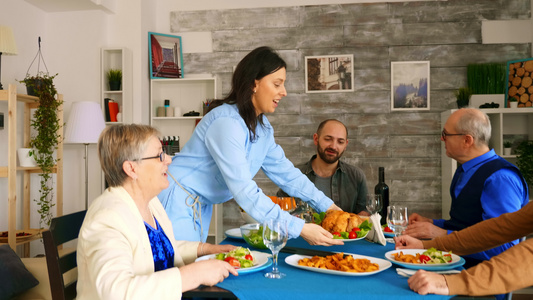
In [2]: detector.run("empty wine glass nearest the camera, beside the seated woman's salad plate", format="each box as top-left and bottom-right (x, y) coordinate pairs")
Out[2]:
(263, 219), (289, 279)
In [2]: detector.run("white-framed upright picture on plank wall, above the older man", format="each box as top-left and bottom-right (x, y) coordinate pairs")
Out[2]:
(391, 61), (429, 110)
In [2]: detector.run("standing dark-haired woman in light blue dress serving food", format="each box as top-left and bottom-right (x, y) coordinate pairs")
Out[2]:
(159, 47), (342, 245)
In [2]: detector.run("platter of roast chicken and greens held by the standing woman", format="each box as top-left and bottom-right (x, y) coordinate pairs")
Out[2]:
(313, 210), (372, 242)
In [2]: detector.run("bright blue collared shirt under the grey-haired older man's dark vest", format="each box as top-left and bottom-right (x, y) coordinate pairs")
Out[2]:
(433, 149), (529, 260)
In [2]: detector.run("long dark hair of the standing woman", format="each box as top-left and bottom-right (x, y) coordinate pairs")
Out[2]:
(209, 46), (287, 141)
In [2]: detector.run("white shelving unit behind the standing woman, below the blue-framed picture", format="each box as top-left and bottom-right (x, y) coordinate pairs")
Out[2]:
(150, 77), (224, 244)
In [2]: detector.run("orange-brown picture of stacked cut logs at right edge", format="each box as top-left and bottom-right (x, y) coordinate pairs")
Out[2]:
(505, 58), (533, 107)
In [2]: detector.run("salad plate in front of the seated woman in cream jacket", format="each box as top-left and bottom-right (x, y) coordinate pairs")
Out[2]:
(196, 247), (272, 275)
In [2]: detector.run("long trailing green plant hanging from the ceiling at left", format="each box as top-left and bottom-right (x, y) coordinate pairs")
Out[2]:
(20, 72), (63, 228)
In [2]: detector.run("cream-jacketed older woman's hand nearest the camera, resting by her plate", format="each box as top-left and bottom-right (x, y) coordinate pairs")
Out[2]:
(180, 259), (239, 292)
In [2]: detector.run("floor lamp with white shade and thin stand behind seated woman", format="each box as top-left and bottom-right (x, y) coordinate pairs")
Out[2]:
(64, 101), (105, 209)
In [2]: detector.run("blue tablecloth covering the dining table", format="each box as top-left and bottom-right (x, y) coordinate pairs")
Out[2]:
(217, 238), (458, 300)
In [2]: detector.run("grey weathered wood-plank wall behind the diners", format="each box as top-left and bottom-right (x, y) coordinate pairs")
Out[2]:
(171, 0), (531, 227)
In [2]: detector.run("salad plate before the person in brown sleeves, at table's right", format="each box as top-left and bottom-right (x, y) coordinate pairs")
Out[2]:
(385, 248), (465, 271)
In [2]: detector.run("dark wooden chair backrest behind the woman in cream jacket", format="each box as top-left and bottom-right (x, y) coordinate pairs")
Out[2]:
(43, 210), (87, 300)
